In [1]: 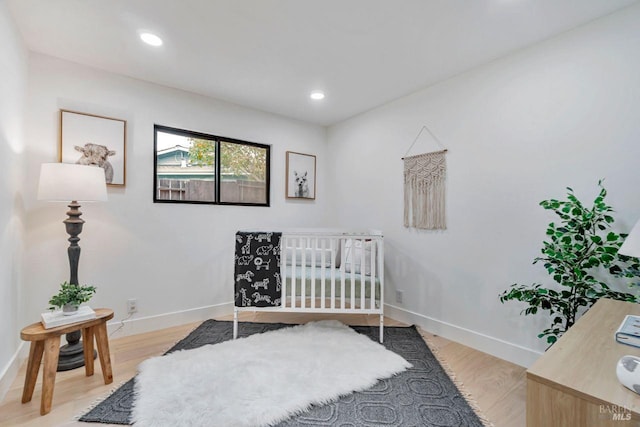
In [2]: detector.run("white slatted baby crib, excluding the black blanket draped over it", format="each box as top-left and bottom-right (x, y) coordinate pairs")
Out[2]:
(233, 230), (384, 342)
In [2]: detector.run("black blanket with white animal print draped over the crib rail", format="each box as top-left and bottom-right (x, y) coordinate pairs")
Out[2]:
(234, 231), (282, 307)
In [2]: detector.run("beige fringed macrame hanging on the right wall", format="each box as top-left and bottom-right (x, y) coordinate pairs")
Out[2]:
(402, 126), (447, 230)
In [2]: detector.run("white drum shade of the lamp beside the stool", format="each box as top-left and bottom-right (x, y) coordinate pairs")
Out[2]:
(38, 163), (107, 202)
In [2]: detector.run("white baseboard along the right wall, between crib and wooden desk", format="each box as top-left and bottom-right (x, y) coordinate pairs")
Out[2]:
(384, 304), (542, 368)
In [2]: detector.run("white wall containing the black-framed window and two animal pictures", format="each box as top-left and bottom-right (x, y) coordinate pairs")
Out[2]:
(25, 54), (328, 338)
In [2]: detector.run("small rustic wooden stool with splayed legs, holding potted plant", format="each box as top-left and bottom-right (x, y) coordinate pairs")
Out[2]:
(20, 308), (113, 415)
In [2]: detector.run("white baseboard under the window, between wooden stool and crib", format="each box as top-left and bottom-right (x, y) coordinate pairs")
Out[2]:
(107, 302), (233, 338)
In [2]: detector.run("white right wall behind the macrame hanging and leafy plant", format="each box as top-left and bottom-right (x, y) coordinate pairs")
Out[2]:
(328, 2), (640, 365)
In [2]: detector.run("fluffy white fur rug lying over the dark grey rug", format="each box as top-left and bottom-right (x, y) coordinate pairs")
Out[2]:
(132, 320), (411, 426)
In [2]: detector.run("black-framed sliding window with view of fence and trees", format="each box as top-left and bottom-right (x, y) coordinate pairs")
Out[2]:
(153, 125), (270, 206)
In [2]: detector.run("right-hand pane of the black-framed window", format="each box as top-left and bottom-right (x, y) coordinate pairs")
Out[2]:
(220, 141), (269, 205)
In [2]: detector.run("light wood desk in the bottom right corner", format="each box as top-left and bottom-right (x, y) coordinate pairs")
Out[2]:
(527, 298), (640, 427)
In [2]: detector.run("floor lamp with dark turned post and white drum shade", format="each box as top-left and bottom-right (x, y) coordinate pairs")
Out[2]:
(38, 163), (107, 371)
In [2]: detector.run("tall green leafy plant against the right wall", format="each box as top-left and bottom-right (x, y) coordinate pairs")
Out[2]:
(499, 181), (640, 344)
